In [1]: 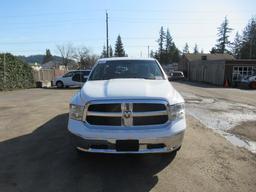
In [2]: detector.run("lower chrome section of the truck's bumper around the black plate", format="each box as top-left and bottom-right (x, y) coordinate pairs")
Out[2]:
(70, 131), (184, 154)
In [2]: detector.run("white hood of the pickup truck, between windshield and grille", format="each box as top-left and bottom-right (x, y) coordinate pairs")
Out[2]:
(80, 79), (184, 104)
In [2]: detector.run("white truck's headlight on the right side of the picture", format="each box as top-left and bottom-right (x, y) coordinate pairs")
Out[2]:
(168, 103), (185, 121)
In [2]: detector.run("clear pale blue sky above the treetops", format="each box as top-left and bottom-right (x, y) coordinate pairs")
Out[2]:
(0, 0), (256, 57)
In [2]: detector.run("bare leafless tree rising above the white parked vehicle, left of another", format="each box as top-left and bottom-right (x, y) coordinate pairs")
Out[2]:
(57, 43), (75, 69)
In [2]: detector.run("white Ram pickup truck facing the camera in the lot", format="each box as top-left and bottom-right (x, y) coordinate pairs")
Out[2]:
(68, 58), (186, 153)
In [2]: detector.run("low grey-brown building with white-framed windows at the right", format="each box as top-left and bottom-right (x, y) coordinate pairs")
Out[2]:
(179, 54), (256, 86)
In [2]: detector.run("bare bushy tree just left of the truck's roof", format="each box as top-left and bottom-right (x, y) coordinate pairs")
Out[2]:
(73, 47), (99, 69)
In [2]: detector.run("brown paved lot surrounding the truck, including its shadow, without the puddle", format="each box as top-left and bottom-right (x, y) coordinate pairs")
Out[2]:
(0, 84), (256, 192)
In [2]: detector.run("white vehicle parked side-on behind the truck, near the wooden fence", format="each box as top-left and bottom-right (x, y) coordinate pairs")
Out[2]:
(53, 70), (91, 88)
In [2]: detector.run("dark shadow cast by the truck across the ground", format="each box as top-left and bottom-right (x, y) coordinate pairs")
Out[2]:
(0, 114), (175, 192)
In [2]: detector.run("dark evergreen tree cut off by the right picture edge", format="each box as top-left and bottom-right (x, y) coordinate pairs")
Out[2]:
(240, 17), (256, 59)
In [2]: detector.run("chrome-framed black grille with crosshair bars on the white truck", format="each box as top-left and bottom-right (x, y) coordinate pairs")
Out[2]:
(84, 101), (168, 126)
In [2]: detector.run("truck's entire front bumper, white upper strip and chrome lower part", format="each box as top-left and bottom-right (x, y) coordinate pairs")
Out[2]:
(68, 118), (186, 154)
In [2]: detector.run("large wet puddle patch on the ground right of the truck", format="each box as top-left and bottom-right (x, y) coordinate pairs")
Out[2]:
(185, 95), (256, 153)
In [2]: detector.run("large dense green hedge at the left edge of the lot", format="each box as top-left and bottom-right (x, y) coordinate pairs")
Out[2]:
(0, 53), (34, 90)
